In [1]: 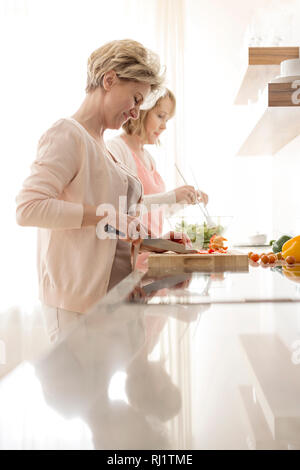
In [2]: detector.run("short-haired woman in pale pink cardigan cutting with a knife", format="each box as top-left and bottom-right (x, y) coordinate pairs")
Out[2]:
(17, 40), (163, 342)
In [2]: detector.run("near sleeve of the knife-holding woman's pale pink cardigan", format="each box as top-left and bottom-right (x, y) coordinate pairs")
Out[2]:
(16, 120), (83, 229)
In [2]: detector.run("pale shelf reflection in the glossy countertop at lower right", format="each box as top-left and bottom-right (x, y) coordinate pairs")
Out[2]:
(239, 334), (300, 445)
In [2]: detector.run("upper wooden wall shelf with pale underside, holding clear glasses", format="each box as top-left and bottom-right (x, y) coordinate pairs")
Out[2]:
(234, 47), (300, 105)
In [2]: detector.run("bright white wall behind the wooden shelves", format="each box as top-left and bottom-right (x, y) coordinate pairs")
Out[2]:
(185, 0), (300, 241)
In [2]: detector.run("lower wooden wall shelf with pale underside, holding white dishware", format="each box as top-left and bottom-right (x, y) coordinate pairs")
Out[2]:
(237, 82), (300, 156)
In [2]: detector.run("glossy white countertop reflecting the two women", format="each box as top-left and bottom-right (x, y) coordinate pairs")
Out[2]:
(0, 258), (300, 449)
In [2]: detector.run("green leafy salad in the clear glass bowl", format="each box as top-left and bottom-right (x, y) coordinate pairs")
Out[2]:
(175, 220), (224, 249)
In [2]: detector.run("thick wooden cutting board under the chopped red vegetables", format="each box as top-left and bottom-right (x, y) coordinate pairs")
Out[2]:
(148, 250), (248, 272)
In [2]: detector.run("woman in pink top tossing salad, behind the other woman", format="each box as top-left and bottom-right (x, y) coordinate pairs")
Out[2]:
(107, 89), (208, 235)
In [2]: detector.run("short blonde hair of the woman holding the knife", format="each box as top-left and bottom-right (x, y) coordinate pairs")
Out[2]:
(85, 39), (164, 93)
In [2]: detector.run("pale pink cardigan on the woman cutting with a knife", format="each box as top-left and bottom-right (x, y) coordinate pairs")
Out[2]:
(16, 118), (139, 313)
